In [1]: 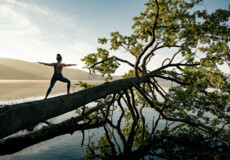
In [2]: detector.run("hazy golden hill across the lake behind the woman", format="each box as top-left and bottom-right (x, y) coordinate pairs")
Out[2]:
(0, 58), (102, 80)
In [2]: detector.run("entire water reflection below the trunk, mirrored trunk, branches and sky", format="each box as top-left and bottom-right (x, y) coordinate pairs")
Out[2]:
(0, 82), (230, 160)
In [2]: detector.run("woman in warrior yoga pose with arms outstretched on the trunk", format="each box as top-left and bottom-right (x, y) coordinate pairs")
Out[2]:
(38, 54), (76, 99)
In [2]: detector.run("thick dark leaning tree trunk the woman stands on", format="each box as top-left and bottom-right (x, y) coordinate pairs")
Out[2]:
(0, 76), (148, 139)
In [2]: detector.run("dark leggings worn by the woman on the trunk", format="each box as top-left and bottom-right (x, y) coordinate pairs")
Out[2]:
(46, 73), (70, 97)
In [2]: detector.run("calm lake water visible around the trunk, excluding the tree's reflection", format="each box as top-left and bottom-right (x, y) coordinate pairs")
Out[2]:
(0, 80), (166, 160)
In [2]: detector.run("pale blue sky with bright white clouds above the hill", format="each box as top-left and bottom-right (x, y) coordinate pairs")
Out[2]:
(0, 0), (230, 75)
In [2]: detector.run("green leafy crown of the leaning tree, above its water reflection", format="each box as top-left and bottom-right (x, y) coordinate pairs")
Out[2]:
(82, 0), (230, 158)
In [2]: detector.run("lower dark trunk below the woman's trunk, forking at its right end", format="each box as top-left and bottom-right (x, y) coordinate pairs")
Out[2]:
(0, 97), (111, 155)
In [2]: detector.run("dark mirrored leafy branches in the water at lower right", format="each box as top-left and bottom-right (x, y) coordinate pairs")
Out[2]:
(84, 90), (230, 160)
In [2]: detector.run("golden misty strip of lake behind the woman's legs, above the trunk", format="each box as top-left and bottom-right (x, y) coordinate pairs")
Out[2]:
(0, 80), (103, 105)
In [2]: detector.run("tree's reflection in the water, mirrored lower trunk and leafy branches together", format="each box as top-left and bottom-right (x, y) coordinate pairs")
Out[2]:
(0, 88), (230, 159)
